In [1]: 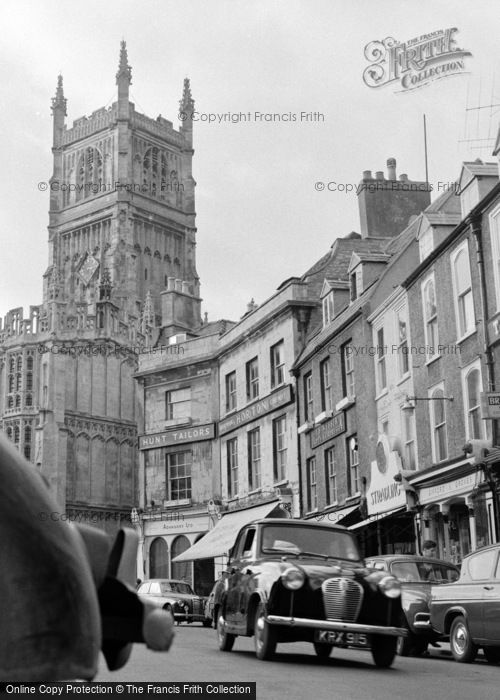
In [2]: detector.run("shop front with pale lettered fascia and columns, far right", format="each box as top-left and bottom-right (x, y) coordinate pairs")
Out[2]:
(412, 461), (494, 565)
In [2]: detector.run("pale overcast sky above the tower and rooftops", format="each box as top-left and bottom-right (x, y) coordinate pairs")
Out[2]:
(0, 0), (500, 320)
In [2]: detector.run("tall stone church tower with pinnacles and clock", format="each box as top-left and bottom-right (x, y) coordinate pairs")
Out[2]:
(0, 42), (202, 529)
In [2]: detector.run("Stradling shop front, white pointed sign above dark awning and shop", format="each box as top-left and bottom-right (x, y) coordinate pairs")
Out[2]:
(349, 434), (416, 557)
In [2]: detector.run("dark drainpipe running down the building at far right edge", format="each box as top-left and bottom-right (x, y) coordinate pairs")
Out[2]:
(468, 216), (500, 542)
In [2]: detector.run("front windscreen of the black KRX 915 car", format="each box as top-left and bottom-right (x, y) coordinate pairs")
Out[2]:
(262, 524), (361, 561)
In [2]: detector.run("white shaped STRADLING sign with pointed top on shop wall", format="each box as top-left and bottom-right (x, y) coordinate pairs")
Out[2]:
(366, 435), (406, 516)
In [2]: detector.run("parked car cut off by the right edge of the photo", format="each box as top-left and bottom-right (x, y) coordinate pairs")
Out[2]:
(430, 543), (500, 663)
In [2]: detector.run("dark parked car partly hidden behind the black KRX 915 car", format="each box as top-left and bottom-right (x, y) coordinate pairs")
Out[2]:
(365, 554), (460, 656)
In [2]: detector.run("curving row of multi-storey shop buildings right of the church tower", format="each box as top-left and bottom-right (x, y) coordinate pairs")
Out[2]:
(134, 152), (500, 592)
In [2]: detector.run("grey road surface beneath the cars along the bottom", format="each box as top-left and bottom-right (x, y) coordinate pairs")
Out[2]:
(95, 624), (500, 700)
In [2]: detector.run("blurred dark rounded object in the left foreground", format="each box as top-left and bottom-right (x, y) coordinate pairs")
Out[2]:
(0, 435), (174, 681)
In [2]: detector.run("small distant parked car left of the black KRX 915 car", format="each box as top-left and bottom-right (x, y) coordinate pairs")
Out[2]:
(137, 578), (212, 627)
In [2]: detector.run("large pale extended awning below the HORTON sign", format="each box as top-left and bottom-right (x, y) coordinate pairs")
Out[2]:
(172, 501), (288, 562)
